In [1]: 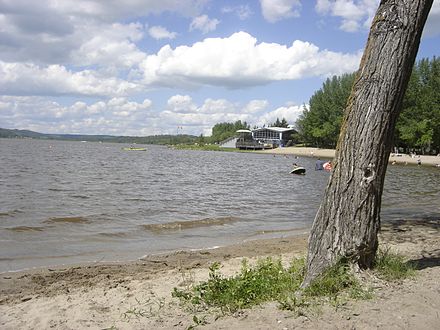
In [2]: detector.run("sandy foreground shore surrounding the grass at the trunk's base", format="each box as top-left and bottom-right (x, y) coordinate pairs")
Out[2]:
(0, 219), (440, 329)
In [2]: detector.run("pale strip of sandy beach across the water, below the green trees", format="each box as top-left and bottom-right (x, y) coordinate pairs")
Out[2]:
(256, 147), (440, 168)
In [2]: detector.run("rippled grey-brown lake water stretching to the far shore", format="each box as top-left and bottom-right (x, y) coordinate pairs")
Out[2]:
(0, 139), (440, 272)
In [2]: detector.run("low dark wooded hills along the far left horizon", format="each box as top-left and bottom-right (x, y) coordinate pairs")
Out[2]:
(0, 128), (197, 144)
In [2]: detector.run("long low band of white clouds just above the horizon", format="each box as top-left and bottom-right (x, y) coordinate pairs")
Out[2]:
(0, 94), (302, 136)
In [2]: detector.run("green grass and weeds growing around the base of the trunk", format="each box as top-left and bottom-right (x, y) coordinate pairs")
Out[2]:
(172, 250), (415, 314)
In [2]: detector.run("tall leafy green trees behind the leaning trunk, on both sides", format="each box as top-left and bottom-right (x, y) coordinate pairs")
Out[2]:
(296, 57), (440, 153)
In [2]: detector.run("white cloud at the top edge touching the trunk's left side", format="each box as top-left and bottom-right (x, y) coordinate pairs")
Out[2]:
(315, 0), (379, 32)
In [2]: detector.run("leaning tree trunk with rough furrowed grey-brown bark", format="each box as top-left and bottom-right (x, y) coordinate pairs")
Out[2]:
(303, 0), (433, 287)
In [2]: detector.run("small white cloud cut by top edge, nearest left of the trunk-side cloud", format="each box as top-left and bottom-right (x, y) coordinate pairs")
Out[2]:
(260, 0), (301, 23)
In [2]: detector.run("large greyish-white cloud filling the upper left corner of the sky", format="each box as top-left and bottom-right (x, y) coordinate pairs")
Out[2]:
(0, 0), (209, 68)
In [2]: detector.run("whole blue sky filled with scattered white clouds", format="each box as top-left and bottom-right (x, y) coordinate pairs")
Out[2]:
(0, 0), (440, 136)
